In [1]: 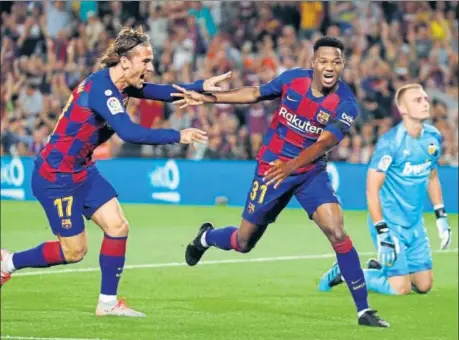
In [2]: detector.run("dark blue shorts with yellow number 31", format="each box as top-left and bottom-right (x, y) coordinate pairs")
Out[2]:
(242, 169), (339, 225)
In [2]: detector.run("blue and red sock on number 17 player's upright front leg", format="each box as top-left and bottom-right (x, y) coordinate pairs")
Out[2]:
(99, 234), (127, 295)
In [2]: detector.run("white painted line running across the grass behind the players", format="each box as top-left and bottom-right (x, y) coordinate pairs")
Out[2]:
(14, 248), (458, 276)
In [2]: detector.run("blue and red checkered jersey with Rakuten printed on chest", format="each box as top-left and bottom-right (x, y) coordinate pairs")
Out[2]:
(257, 68), (358, 176)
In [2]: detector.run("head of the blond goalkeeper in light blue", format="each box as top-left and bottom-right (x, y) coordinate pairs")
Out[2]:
(400, 88), (430, 121)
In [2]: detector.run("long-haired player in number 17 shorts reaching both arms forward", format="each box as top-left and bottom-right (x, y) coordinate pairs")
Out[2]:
(1, 28), (230, 317)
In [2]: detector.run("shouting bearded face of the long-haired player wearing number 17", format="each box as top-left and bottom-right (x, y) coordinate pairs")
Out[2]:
(122, 44), (153, 88)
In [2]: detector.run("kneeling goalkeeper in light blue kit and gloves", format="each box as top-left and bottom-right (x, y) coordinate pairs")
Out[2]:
(319, 84), (451, 295)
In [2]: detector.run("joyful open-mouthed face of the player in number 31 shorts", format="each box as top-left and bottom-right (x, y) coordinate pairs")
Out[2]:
(312, 46), (344, 89)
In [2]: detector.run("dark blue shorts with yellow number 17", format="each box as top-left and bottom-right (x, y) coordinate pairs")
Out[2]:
(32, 167), (118, 237)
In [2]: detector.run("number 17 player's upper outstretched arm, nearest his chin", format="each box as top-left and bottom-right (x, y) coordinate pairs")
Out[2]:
(125, 72), (231, 102)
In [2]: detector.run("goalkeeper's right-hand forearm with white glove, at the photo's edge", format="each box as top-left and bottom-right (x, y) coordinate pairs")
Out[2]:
(427, 169), (451, 250)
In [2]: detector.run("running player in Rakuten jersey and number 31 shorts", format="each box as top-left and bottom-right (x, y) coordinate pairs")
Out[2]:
(173, 37), (389, 327)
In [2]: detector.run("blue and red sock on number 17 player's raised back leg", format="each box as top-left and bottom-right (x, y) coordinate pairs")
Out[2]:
(13, 241), (67, 269)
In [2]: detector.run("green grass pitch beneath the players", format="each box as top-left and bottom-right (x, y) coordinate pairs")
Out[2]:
(1, 201), (458, 340)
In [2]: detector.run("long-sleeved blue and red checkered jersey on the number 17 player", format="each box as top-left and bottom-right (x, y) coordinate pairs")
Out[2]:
(35, 69), (203, 183)
